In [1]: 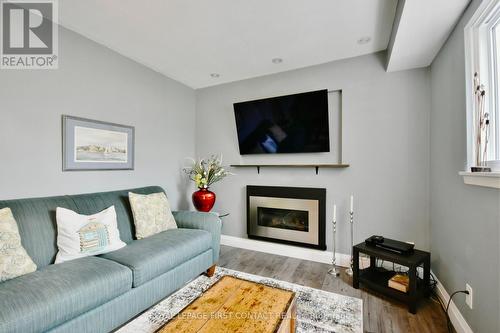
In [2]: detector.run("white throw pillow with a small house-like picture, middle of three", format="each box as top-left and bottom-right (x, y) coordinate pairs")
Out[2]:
(56, 206), (126, 264)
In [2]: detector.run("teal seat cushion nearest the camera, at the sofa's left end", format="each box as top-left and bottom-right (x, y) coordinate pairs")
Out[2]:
(0, 257), (132, 333)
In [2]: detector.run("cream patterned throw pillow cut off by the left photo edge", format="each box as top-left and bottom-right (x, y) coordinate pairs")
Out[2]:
(0, 208), (36, 282)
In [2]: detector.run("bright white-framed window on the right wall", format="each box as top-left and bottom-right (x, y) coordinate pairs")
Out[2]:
(465, 0), (500, 171)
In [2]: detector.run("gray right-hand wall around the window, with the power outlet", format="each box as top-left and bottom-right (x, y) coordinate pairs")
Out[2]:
(430, 1), (500, 333)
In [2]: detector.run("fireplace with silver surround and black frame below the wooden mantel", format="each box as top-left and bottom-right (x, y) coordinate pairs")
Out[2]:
(247, 185), (326, 250)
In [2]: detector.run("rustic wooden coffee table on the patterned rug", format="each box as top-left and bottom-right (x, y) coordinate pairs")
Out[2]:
(157, 276), (297, 333)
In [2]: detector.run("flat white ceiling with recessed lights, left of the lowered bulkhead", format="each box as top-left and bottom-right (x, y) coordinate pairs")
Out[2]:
(59, 0), (396, 88)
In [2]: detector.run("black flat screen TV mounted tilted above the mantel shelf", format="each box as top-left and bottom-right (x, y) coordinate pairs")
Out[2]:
(234, 89), (330, 155)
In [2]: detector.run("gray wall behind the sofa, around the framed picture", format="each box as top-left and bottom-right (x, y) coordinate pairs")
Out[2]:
(0, 28), (196, 208)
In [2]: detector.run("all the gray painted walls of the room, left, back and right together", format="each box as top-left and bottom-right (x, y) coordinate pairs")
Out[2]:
(0, 12), (494, 332)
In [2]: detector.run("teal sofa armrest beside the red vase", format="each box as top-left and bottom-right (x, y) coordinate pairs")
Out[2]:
(172, 211), (222, 264)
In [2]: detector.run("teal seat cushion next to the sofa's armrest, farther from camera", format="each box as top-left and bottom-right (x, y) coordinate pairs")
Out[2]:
(101, 229), (212, 287)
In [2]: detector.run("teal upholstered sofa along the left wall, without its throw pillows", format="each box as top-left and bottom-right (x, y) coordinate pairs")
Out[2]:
(0, 187), (221, 333)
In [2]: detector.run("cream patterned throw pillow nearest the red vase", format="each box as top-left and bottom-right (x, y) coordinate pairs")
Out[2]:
(128, 192), (177, 239)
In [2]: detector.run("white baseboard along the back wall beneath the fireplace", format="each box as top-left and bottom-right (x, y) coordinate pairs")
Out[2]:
(220, 235), (369, 267)
